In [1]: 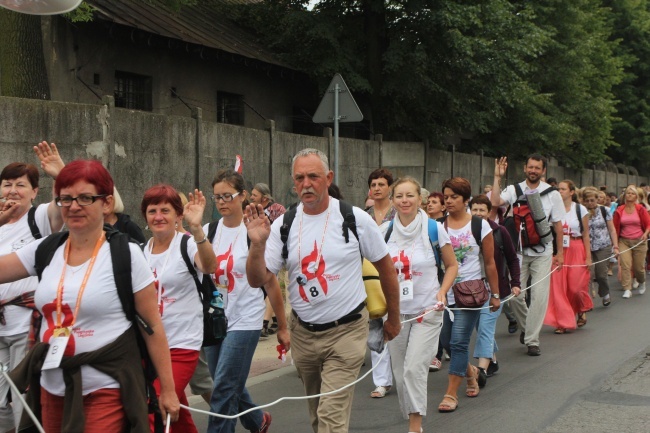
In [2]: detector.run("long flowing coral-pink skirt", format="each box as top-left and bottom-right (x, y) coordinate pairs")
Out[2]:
(544, 238), (594, 329)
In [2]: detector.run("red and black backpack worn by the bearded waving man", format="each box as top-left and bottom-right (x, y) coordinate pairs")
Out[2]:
(503, 183), (557, 253)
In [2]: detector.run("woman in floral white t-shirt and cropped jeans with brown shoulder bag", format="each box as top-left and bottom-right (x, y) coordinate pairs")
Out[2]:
(438, 177), (501, 412)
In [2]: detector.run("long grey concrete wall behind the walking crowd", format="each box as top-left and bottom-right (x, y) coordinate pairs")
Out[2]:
(0, 97), (648, 230)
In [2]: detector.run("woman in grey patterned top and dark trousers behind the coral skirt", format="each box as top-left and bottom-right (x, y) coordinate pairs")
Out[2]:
(582, 186), (618, 307)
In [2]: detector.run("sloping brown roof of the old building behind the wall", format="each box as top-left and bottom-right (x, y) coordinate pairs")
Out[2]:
(87, 0), (289, 67)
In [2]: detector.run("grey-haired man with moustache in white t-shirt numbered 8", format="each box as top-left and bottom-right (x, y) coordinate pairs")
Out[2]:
(244, 149), (401, 433)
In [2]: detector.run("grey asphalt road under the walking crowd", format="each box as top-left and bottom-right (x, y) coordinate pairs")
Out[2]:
(194, 277), (650, 433)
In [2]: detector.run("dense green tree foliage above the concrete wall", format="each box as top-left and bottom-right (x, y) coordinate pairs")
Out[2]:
(223, 0), (628, 165)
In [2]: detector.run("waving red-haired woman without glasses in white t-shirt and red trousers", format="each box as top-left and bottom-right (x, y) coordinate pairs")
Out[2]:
(140, 184), (216, 433)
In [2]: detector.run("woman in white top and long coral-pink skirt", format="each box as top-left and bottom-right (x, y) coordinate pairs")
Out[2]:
(544, 180), (594, 334)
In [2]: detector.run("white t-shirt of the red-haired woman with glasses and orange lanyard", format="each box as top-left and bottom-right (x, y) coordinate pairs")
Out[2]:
(17, 236), (153, 396)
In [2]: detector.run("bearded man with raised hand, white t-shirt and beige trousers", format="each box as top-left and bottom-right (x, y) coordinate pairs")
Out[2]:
(491, 154), (565, 356)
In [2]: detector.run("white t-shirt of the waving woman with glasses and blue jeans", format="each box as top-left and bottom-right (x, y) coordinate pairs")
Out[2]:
(203, 222), (266, 331)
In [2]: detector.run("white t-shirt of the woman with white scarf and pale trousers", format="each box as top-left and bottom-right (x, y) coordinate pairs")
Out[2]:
(387, 221), (450, 314)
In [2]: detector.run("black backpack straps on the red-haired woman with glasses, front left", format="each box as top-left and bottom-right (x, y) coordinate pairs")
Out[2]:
(34, 224), (164, 433)
